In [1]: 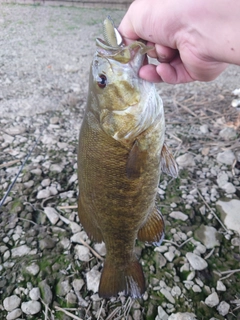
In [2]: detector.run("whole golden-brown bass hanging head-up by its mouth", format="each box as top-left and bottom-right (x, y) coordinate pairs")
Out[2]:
(78, 17), (178, 298)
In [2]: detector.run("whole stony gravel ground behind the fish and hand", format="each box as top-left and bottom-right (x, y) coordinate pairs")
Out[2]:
(0, 3), (240, 320)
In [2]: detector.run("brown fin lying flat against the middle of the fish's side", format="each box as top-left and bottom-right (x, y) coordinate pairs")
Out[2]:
(126, 140), (148, 179)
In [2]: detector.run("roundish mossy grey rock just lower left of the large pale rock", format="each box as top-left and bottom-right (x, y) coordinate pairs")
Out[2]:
(194, 225), (221, 249)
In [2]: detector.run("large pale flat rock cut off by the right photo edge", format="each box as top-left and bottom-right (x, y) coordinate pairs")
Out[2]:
(216, 199), (240, 234)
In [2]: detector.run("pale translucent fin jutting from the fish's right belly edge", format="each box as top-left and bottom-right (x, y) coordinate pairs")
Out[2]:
(161, 143), (178, 178)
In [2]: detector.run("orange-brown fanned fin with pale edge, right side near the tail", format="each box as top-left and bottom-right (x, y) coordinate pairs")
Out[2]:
(138, 207), (164, 246)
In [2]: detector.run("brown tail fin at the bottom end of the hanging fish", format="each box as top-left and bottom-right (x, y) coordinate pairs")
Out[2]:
(99, 259), (145, 298)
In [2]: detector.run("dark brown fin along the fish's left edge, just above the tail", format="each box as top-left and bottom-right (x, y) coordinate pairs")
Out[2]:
(78, 197), (104, 242)
